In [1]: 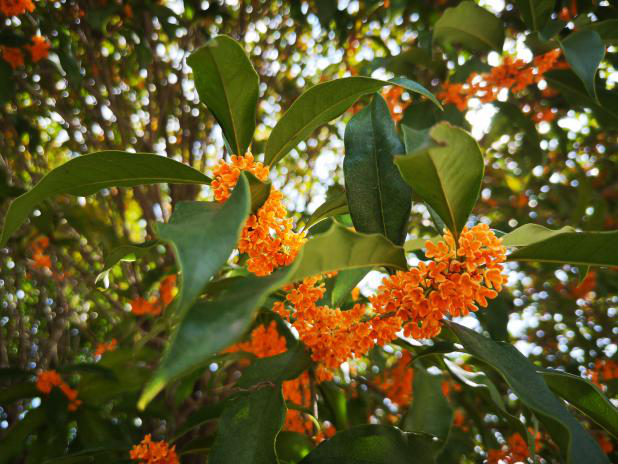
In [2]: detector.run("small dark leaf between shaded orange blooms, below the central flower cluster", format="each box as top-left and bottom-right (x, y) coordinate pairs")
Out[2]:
(238, 343), (311, 388)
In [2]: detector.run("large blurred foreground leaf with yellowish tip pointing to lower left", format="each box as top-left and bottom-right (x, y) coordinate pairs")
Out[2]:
(138, 260), (302, 409)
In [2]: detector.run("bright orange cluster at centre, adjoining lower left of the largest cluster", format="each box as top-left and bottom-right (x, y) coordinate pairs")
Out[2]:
(273, 277), (400, 381)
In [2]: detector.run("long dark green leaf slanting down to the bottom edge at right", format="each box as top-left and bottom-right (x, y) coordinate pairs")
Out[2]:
(446, 321), (609, 464)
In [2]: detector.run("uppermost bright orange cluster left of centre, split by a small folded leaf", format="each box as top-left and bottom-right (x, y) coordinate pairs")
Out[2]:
(211, 153), (305, 276)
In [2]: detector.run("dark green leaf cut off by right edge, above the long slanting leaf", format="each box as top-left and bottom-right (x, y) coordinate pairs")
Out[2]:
(540, 370), (618, 438)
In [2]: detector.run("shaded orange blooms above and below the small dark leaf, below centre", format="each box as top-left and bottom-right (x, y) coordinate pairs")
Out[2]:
(226, 321), (313, 435)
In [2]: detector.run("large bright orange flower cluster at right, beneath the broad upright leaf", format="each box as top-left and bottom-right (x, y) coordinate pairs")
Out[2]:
(369, 224), (506, 339)
